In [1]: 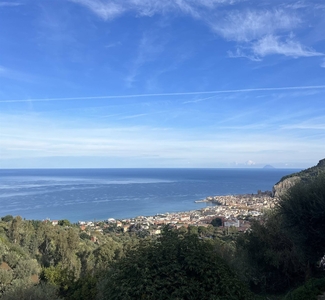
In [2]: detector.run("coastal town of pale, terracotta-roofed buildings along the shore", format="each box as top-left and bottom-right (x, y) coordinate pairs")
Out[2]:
(65, 191), (278, 241)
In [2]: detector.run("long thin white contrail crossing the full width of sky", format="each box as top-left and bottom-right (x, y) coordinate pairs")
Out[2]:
(0, 85), (325, 103)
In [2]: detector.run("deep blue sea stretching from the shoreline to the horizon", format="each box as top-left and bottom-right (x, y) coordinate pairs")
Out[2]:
(0, 168), (300, 222)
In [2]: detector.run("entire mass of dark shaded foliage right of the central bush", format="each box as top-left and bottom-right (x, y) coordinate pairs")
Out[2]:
(234, 174), (325, 294)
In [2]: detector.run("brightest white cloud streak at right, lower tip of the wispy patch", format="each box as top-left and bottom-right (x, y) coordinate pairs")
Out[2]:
(252, 35), (324, 58)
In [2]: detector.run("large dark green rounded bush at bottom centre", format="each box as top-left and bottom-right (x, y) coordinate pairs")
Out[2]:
(99, 227), (251, 300)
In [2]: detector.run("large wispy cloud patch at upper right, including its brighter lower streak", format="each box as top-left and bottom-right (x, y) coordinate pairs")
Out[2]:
(211, 9), (323, 61)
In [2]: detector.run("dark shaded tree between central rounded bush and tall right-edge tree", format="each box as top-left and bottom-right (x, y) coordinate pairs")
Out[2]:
(233, 213), (304, 293)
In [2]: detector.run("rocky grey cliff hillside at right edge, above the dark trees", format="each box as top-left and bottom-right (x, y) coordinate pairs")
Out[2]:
(273, 158), (325, 197)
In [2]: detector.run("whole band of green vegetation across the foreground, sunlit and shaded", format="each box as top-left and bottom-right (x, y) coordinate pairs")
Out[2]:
(0, 174), (325, 300)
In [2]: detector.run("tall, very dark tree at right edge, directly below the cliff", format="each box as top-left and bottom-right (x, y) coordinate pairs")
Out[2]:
(277, 173), (325, 275)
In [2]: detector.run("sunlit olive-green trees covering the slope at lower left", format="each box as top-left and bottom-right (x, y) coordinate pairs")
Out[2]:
(0, 216), (138, 299)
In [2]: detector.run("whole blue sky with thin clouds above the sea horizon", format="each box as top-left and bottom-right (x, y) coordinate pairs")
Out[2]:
(0, 0), (325, 168)
